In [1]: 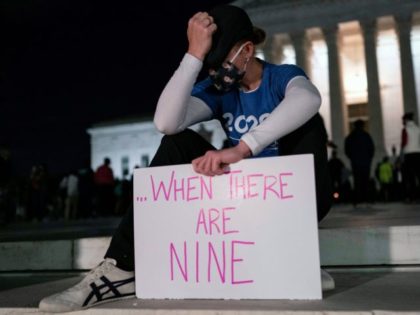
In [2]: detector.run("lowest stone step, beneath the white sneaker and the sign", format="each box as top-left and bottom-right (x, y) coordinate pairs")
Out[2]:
(0, 267), (420, 315)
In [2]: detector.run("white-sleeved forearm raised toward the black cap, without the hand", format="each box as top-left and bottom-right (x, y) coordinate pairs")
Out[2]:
(154, 54), (202, 134)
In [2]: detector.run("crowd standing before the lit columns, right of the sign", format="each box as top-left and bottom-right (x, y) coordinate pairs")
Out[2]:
(328, 113), (420, 206)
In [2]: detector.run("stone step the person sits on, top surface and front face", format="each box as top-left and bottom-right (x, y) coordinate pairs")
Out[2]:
(0, 204), (420, 271)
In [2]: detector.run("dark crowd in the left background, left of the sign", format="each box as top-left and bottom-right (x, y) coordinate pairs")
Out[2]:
(0, 154), (132, 223)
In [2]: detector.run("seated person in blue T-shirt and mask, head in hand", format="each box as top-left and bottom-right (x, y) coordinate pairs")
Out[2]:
(40, 5), (334, 311)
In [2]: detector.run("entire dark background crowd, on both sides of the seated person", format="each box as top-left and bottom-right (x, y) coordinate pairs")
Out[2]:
(0, 113), (420, 223)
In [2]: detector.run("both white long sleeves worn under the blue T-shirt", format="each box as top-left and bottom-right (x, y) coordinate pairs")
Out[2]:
(154, 54), (321, 155)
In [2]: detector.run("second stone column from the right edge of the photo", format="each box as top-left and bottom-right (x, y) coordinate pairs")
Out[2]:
(360, 19), (386, 159)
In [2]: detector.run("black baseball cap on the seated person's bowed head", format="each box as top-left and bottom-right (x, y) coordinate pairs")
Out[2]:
(204, 5), (254, 69)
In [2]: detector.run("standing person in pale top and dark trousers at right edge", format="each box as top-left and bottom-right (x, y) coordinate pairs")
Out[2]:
(401, 113), (420, 202)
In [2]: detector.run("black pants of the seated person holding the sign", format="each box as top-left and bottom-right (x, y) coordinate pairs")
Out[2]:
(105, 116), (332, 270)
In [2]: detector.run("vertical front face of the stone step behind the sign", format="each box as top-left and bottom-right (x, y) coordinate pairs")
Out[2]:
(0, 225), (420, 271)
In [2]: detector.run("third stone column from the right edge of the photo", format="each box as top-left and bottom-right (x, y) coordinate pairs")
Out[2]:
(322, 25), (348, 156)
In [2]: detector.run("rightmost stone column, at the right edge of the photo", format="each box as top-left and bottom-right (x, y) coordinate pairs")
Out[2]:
(395, 14), (419, 122)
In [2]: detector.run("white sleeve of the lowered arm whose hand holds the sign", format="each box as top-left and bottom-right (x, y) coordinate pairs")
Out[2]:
(241, 76), (321, 155)
